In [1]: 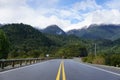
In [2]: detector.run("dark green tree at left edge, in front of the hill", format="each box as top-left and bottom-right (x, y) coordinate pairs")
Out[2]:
(0, 30), (10, 59)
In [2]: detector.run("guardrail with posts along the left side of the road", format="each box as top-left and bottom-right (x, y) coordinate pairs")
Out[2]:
(0, 58), (48, 70)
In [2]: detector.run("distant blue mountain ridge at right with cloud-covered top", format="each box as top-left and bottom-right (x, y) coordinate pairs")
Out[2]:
(67, 24), (120, 40)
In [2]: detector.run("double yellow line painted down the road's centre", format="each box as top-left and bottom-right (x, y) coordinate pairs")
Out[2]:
(56, 61), (66, 80)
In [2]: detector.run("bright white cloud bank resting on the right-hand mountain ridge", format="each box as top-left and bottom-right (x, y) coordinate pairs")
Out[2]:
(66, 9), (120, 30)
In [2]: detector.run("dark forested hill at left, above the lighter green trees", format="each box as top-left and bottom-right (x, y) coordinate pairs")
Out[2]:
(0, 23), (53, 48)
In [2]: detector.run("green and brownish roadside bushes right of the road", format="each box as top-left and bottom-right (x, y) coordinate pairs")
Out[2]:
(82, 48), (120, 67)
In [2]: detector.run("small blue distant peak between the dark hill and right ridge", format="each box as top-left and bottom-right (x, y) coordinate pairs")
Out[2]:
(41, 25), (66, 35)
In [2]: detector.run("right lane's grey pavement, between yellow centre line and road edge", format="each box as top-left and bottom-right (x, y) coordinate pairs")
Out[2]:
(64, 60), (120, 80)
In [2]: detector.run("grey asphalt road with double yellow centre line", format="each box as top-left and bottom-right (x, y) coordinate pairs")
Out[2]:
(0, 59), (120, 80)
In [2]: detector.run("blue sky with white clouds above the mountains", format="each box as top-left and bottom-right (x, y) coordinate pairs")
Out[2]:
(0, 0), (120, 31)
